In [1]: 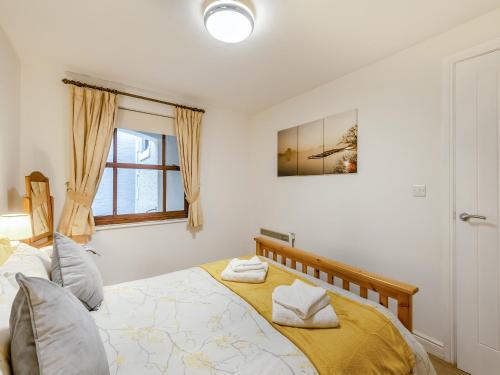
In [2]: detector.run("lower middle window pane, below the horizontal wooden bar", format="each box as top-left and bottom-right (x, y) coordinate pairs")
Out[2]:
(117, 169), (163, 215)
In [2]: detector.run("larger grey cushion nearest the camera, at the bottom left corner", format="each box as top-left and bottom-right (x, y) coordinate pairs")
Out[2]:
(10, 273), (109, 375)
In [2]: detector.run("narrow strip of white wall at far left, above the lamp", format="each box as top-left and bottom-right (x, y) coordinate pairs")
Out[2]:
(0, 28), (20, 214)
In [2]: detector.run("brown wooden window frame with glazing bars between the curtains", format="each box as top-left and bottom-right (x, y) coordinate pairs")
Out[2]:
(94, 128), (189, 226)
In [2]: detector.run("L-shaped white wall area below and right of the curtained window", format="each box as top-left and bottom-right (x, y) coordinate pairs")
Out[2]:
(92, 106), (253, 283)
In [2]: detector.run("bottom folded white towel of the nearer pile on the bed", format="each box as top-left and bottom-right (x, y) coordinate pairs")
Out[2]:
(273, 301), (339, 328)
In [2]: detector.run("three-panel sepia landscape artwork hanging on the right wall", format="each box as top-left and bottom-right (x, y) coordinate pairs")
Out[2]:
(278, 109), (358, 177)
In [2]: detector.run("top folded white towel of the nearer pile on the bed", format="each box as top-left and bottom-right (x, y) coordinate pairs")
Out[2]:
(273, 279), (330, 319)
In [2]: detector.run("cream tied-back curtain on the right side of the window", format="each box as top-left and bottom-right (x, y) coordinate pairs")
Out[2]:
(175, 107), (203, 229)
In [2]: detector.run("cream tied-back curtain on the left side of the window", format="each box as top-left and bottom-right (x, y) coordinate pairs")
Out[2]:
(59, 86), (118, 236)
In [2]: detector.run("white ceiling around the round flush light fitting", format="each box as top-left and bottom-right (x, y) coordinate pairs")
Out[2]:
(0, 0), (500, 113)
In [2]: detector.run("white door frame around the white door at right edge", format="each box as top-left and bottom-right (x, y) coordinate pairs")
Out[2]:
(448, 38), (500, 364)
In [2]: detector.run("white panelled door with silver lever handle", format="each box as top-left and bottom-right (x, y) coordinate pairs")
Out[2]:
(454, 51), (500, 375)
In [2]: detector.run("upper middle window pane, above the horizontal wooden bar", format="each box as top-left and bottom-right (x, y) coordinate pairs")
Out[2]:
(117, 129), (162, 165)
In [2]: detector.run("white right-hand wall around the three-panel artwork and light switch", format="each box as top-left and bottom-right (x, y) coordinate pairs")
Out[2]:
(252, 10), (500, 358)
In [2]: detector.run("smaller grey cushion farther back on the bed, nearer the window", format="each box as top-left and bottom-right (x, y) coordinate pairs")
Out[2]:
(51, 233), (104, 310)
